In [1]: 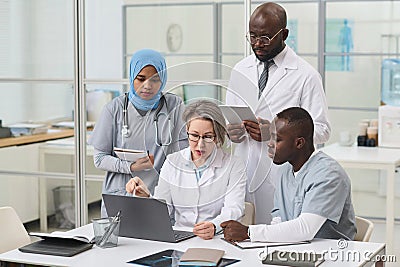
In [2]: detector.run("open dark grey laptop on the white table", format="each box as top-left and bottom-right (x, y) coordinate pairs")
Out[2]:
(103, 194), (195, 243)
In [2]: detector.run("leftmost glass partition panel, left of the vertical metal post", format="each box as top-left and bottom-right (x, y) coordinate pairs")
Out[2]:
(0, 0), (75, 231)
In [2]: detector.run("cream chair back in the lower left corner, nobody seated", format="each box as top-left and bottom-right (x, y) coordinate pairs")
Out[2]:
(0, 207), (31, 253)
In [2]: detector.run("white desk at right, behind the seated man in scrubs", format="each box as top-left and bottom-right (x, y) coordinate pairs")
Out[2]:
(321, 143), (400, 253)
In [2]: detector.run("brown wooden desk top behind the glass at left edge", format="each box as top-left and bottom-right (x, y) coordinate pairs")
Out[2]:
(0, 129), (74, 148)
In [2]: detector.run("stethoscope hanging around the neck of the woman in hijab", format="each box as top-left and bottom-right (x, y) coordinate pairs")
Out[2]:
(121, 93), (172, 146)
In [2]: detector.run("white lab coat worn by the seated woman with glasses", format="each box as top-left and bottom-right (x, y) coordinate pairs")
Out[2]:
(154, 148), (246, 231)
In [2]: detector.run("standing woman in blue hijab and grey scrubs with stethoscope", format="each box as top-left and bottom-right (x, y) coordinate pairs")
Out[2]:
(89, 49), (188, 217)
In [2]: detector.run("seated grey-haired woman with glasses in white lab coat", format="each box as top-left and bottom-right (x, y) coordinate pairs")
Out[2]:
(126, 100), (246, 239)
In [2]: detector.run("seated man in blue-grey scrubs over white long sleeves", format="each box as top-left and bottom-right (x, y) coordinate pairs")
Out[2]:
(221, 107), (356, 242)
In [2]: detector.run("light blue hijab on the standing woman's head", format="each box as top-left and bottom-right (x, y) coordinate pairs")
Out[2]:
(129, 49), (167, 111)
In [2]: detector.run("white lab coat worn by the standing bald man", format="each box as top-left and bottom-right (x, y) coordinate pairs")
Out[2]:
(226, 46), (331, 226)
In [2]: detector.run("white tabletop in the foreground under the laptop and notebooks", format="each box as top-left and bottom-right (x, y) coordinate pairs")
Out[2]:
(0, 224), (385, 267)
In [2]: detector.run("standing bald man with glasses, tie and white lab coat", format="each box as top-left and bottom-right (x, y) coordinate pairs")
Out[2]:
(226, 2), (331, 223)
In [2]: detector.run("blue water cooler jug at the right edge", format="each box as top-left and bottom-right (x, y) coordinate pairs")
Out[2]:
(381, 59), (400, 106)
